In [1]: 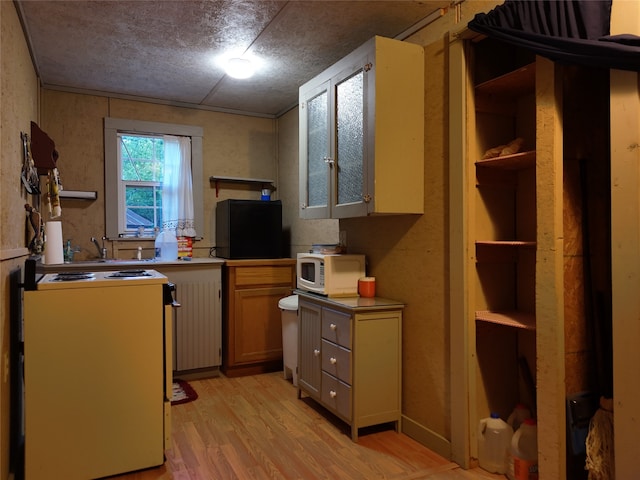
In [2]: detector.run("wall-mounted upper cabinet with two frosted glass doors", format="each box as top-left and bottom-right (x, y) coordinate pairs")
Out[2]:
(300, 37), (424, 218)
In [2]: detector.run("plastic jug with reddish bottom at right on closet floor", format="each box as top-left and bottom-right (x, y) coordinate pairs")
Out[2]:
(507, 418), (538, 480)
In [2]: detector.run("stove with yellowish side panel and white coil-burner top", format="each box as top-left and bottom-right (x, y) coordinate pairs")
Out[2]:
(23, 270), (172, 480)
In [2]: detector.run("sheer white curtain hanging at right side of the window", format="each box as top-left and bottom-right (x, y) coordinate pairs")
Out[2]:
(162, 135), (196, 237)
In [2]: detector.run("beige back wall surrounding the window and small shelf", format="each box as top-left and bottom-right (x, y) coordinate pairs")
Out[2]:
(40, 90), (278, 258)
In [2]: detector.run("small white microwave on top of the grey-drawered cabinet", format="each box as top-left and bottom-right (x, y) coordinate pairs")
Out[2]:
(296, 253), (365, 297)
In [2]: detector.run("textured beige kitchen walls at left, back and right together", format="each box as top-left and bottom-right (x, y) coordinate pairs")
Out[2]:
(0, 0), (636, 479)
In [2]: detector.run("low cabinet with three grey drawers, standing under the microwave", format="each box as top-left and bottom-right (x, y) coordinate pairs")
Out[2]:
(296, 291), (404, 442)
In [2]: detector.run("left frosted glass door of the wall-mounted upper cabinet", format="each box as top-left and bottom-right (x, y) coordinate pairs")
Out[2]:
(300, 82), (332, 218)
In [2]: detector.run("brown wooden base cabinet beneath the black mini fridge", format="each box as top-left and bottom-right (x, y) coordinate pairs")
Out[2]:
(222, 258), (296, 377)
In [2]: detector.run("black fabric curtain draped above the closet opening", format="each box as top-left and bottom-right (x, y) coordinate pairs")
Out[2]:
(468, 0), (640, 71)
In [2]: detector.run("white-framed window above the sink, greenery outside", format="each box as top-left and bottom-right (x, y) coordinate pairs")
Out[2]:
(105, 118), (204, 238)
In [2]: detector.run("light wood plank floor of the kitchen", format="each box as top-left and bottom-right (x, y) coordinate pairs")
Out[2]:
(112, 372), (506, 480)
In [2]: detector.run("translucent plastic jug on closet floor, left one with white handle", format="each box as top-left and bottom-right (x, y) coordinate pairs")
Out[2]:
(478, 412), (513, 474)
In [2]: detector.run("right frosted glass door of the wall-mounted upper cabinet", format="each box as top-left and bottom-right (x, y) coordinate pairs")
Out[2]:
(334, 69), (365, 217)
